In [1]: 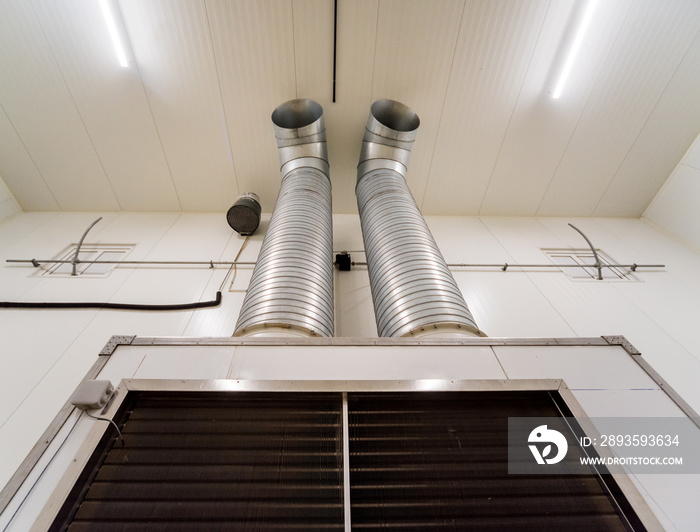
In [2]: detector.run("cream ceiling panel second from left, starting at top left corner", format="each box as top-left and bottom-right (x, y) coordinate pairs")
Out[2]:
(0, 1), (119, 210)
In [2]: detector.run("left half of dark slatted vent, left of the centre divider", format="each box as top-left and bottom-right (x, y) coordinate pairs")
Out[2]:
(52, 392), (343, 532)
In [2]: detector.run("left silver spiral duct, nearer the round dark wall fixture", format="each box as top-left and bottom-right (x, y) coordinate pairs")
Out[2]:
(234, 100), (333, 336)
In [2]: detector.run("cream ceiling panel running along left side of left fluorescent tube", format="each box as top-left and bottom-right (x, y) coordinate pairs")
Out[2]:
(32, 0), (180, 211)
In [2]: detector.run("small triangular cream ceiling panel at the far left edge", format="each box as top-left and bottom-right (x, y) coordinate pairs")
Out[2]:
(0, 108), (58, 211)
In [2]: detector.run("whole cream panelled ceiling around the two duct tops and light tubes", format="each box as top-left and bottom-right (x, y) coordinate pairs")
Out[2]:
(0, 0), (700, 217)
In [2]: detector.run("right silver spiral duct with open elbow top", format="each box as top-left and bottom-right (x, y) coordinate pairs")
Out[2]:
(355, 100), (482, 337)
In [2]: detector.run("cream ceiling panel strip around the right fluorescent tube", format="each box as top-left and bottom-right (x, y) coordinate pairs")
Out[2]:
(482, 0), (632, 216)
